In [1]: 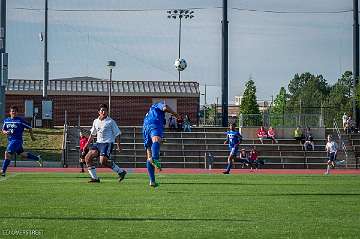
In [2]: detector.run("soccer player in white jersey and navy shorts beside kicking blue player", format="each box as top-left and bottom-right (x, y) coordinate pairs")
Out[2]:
(85, 104), (126, 183)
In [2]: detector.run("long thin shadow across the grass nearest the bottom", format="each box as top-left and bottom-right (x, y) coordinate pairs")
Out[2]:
(0, 216), (251, 222)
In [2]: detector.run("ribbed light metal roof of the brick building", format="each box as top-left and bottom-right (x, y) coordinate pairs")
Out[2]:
(6, 77), (200, 97)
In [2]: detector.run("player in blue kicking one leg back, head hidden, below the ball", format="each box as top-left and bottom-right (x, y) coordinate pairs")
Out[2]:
(143, 102), (178, 187)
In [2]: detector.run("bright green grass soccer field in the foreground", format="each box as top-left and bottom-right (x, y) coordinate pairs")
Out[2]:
(0, 173), (360, 238)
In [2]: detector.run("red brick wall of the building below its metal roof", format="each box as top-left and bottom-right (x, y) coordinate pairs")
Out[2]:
(6, 95), (200, 126)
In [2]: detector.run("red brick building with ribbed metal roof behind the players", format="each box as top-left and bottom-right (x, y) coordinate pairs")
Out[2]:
(6, 77), (200, 126)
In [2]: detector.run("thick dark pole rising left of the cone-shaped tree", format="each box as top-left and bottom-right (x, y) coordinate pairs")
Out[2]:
(221, 0), (229, 127)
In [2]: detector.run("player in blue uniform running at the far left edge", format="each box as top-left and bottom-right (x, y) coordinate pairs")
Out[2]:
(1, 106), (42, 177)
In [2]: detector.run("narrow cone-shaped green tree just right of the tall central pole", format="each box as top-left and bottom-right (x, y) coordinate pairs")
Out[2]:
(239, 79), (261, 126)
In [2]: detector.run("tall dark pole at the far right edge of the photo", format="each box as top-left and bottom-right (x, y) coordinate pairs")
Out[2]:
(353, 0), (360, 127)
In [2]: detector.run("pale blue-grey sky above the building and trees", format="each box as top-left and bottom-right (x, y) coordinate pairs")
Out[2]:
(6, 0), (353, 103)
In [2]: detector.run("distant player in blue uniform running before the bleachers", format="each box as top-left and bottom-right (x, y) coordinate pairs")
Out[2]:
(223, 123), (242, 174)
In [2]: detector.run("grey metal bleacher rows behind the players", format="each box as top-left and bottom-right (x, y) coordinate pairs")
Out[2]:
(67, 127), (354, 169)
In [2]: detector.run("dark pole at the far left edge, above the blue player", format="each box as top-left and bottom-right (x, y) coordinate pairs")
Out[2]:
(0, 0), (8, 118)
